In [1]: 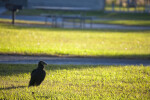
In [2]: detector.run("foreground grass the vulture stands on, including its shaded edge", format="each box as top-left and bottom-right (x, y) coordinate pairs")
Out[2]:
(0, 64), (150, 100)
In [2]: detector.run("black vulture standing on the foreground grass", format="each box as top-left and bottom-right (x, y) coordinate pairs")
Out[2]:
(29, 61), (47, 86)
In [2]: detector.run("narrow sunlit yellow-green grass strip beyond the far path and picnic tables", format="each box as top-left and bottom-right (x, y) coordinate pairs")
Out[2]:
(0, 19), (150, 26)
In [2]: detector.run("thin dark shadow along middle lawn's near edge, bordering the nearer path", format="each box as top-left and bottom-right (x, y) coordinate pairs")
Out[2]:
(0, 52), (150, 59)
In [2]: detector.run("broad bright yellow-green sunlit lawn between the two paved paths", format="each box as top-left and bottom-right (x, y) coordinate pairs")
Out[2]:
(0, 19), (150, 58)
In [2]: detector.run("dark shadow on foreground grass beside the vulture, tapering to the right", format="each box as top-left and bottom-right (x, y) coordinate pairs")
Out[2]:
(0, 64), (108, 78)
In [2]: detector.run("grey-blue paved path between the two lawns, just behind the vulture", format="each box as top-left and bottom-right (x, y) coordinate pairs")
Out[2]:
(0, 55), (150, 66)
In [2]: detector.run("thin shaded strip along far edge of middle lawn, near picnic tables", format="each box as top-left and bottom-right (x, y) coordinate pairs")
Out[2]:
(0, 22), (150, 34)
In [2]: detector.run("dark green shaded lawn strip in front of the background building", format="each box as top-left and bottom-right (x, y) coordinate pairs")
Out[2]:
(3, 9), (150, 20)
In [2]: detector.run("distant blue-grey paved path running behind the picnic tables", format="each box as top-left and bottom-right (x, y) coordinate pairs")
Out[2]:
(0, 15), (150, 30)
